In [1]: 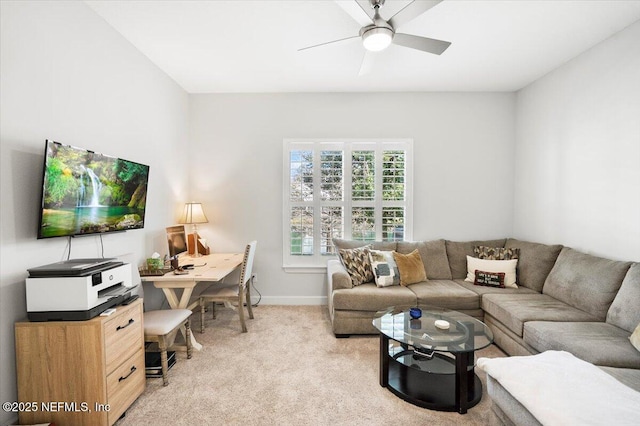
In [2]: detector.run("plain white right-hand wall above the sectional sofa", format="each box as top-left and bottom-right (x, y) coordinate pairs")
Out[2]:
(514, 22), (640, 261)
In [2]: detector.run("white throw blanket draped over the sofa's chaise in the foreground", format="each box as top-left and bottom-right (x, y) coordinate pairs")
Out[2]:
(478, 351), (640, 426)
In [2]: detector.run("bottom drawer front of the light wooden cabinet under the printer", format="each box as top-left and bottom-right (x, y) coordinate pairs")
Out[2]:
(107, 349), (146, 425)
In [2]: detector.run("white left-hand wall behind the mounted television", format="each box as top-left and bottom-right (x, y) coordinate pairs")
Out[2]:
(0, 1), (188, 424)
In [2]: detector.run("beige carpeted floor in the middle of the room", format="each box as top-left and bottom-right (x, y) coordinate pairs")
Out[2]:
(116, 306), (504, 426)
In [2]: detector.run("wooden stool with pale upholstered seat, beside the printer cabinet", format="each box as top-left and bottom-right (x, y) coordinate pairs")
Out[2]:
(143, 309), (191, 386)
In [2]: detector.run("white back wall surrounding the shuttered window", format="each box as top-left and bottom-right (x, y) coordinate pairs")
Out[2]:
(190, 93), (515, 303)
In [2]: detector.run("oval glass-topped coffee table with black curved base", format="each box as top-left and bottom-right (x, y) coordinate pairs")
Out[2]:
(373, 306), (493, 414)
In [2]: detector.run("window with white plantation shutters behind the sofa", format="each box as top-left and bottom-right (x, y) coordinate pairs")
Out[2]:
(283, 139), (413, 268)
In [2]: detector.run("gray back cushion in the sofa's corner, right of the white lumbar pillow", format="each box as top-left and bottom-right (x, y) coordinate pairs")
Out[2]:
(504, 238), (562, 293)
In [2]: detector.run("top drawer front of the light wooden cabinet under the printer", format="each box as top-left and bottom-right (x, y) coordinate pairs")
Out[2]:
(104, 304), (144, 374)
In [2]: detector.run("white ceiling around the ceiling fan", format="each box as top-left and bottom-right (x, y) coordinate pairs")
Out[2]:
(86, 0), (640, 93)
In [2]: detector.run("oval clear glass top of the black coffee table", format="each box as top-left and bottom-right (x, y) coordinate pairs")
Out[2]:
(373, 306), (493, 353)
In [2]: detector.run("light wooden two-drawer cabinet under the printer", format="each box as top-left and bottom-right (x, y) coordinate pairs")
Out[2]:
(15, 299), (145, 425)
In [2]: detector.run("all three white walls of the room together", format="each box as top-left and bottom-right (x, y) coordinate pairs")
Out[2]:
(0, 2), (640, 424)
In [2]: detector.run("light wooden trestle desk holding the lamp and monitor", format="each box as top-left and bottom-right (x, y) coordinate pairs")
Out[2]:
(141, 253), (244, 351)
